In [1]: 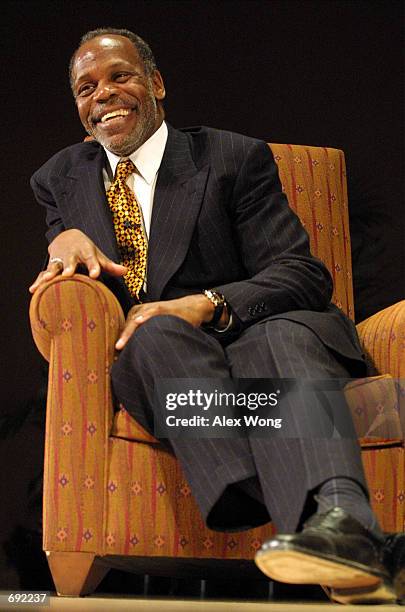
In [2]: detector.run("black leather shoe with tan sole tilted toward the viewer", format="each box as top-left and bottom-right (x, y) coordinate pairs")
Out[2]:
(255, 507), (395, 603)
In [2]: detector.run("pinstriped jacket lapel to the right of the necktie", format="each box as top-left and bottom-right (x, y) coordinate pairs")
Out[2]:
(147, 126), (209, 301)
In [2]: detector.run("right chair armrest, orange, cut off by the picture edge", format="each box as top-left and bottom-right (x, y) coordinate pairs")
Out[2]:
(357, 300), (405, 379)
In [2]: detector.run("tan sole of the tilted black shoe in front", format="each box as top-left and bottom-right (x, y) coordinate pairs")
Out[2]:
(255, 549), (383, 589)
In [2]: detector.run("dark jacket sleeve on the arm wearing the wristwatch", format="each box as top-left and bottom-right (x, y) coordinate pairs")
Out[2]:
(216, 141), (332, 325)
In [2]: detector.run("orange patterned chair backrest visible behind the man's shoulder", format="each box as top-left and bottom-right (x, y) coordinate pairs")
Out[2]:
(269, 143), (354, 319)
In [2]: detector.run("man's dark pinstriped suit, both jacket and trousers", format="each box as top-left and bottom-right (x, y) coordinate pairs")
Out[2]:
(31, 127), (365, 531)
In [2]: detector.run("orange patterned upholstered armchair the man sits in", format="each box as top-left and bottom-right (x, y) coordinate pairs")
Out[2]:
(30, 144), (405, 595)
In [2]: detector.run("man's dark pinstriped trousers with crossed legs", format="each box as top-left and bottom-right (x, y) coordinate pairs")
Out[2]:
(111, 315), (367, 533)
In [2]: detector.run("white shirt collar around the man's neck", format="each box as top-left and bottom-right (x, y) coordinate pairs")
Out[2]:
(104, 121), (168, 185)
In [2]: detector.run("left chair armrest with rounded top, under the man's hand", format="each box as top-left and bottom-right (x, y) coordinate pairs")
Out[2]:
(30, 275), (124, 553)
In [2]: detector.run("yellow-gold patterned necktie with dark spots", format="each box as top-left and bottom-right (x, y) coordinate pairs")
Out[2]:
(107, 159), (148, 300)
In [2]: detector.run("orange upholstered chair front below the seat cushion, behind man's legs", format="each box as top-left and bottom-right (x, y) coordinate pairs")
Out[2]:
(104, 438), (274, 559)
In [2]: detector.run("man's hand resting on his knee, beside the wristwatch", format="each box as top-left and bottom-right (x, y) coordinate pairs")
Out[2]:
(115, 294), (214, 350)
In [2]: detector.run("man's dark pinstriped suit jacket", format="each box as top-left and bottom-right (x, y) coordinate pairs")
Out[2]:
(31, 126), (364, 375)
